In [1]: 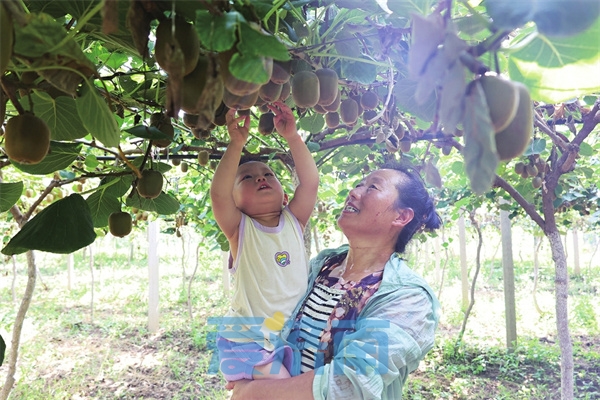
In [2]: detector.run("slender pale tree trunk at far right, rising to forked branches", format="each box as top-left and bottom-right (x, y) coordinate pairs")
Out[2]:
(546, 228), (573, 400)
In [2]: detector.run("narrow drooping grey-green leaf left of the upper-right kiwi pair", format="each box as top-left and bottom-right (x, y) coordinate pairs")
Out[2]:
(463, 81), (499, 194)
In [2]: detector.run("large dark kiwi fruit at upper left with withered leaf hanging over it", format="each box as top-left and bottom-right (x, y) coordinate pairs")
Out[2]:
(154, 17), (200, 75)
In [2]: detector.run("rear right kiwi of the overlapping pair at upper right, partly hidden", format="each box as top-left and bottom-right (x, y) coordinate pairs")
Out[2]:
(495, 82), (533, 161)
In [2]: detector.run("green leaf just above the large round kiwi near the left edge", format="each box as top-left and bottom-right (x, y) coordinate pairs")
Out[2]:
(28, 91), (88, 140)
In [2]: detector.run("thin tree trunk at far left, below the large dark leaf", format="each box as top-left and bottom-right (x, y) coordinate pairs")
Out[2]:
(0, 250), (37, 400)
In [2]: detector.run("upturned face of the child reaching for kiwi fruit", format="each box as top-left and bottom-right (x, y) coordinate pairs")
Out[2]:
(233, 161), (287, 217)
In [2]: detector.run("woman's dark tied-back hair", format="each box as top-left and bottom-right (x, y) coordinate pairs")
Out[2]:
(381, 162), (442, 253)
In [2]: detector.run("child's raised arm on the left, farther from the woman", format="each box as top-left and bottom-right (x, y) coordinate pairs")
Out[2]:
(210, 109), (250, 243)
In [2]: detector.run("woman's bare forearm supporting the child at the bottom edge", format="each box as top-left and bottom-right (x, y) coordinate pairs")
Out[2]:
(227, 371), (315, 400)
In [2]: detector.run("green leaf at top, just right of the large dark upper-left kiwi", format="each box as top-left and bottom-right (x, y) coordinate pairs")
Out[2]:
(195, 10), (237, 53)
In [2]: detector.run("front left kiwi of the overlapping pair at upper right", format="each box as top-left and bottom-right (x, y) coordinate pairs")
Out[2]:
(479, 75), (519, 133)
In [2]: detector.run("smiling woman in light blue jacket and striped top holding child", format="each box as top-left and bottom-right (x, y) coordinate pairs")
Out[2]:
(228, 165), (441, 400)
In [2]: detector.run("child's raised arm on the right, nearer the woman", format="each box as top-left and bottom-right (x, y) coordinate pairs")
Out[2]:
(268, 102), (319, 227)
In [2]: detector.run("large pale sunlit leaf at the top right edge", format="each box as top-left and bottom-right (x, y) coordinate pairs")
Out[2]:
(508, 19), (600, 103)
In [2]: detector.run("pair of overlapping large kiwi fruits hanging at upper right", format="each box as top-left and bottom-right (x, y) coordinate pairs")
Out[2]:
(477, 75), (533, 161)
